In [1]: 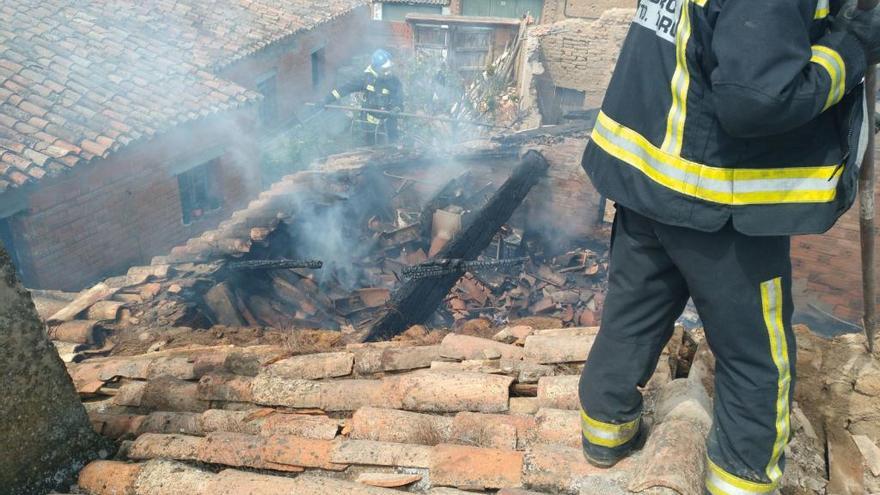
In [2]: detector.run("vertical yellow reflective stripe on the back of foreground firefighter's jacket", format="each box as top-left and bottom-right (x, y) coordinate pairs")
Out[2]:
(660, 0), (691, 155)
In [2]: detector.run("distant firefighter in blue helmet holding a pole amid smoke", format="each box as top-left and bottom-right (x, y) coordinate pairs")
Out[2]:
(324, 50), (403, 146)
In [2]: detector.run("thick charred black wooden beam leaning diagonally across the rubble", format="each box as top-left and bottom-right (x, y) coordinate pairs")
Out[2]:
(366, 151), (550, 341)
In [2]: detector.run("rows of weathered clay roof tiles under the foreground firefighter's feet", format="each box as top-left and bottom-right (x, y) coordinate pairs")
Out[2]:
(70, 328), (710, 495)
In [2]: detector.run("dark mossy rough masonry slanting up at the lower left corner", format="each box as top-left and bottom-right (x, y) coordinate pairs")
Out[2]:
(0, 248), (111, 495)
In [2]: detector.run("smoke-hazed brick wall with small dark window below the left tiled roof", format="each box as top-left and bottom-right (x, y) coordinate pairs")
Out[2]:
(12, 108), (260, 291)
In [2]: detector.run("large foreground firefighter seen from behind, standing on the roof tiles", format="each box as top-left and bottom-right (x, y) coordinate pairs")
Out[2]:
(579, 0), (880, 495)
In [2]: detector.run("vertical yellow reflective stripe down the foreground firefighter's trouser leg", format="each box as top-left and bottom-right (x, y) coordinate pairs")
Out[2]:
(761, 277), (791, 483)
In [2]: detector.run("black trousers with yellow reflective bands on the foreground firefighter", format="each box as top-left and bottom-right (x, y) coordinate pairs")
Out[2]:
(579, 207), (796, 495)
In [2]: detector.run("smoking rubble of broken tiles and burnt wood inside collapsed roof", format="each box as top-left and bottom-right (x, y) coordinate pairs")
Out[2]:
(39, 132), (607, 359)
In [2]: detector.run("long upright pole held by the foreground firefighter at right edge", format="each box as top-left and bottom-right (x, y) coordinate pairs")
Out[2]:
(859, 0), (880, 353)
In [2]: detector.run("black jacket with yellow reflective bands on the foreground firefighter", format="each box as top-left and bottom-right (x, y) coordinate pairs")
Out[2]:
(583, 0), (868, 235)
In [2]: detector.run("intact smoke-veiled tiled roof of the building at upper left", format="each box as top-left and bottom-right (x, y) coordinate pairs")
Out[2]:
(0, 0), (365, 189)
